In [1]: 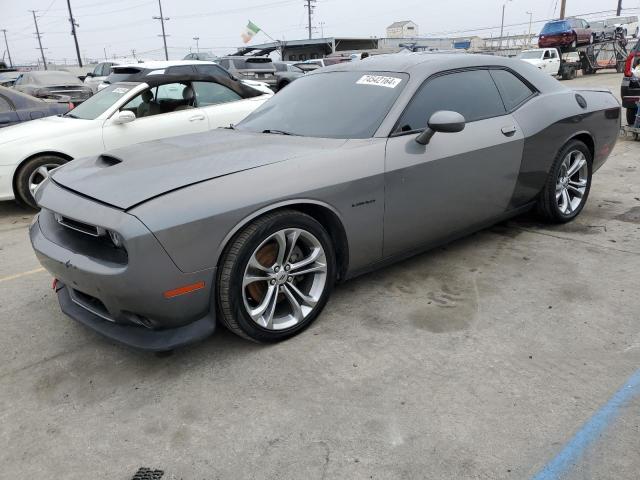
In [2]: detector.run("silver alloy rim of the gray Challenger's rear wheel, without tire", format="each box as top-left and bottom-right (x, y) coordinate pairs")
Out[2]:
(556, 150), (589, 215)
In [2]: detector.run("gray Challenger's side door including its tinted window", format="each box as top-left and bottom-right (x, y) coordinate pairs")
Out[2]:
(384, 69), (533, 257)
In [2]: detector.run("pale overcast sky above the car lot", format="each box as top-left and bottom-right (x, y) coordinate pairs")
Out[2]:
(0, 0), (640, 64)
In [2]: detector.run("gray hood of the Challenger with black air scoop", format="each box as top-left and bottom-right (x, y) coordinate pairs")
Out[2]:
(51, 129), (346, 210)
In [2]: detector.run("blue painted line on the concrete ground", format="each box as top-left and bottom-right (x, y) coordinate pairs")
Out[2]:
(532, 370), (640, 480)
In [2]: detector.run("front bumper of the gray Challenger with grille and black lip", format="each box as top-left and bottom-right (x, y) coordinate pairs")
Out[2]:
(29, 182), (216, 350)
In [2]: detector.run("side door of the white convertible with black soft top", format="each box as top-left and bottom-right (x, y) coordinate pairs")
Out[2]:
(102, 83), (208, 150)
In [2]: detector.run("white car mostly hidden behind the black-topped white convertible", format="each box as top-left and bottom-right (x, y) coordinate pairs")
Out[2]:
(98, 60), (273, 94)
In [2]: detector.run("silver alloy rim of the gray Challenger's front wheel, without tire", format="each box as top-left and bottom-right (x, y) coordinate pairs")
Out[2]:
(242, 228), (327, 330)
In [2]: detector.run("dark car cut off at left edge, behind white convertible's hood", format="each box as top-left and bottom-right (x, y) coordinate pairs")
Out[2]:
(0, 87), (73, 128)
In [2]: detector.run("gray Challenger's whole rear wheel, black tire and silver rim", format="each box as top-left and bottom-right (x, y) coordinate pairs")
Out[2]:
(537, 140), (593, 223)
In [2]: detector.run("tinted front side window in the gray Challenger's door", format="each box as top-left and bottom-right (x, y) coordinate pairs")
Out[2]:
(396, 70), (506, 132)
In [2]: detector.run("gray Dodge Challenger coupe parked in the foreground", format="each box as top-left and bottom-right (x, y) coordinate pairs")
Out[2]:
(30, 54), (620, 351)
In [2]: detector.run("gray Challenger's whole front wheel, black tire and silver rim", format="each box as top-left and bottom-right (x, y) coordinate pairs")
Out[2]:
(217, 210), (336, 343)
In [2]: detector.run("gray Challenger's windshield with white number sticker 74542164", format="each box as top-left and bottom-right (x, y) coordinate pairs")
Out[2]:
(237, 72), (409, 138)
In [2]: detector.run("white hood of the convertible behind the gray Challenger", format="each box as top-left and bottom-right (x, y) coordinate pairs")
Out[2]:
(0, 116), (94, 145)
